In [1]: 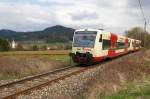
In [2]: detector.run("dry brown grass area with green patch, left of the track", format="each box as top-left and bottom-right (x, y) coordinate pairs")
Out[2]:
(0, 54), (70, 80)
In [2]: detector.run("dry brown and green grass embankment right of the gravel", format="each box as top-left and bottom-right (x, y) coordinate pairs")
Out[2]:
(81, 50), (150, 99)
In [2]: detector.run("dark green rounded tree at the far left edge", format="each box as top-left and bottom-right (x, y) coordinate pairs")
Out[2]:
(0, 38), (10, 51)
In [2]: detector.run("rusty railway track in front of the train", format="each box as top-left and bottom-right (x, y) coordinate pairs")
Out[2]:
(0, 62), (101, 99)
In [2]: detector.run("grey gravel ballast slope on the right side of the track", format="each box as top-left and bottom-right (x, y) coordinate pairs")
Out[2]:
(17, 66), (105, 99)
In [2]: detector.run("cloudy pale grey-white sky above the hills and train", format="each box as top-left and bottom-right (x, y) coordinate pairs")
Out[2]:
(0, 0), (150, 33)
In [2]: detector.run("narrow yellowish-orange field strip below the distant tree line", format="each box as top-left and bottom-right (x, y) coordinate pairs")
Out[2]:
(0, 50), (70, 55)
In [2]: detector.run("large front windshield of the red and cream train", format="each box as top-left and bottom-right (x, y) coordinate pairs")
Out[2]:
(73, 31), (97, 48)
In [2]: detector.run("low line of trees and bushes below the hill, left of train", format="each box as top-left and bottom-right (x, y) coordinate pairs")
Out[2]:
(0, 38), (72, 52)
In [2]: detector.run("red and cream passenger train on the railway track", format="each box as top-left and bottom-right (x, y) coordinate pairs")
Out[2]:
(70, 29), (141, 64)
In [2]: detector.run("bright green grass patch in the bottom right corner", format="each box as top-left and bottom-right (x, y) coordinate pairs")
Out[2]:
(99, 80), (150, 99)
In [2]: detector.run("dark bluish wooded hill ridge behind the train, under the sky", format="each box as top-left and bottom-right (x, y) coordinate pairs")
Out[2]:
(0, 25), (74, 42)
